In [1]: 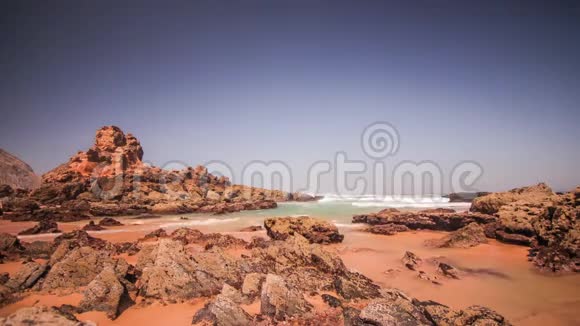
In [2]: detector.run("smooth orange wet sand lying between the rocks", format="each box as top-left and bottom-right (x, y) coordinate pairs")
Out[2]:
(0, 220), (580, 325)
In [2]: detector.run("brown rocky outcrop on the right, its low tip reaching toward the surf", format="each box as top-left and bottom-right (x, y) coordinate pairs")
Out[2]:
(352, 183), (580, 272)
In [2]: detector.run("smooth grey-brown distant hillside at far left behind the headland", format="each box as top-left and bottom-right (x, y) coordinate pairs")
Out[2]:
(0, 148), (40, 189)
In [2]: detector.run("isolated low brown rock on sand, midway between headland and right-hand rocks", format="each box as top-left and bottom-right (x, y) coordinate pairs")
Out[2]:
(264, 216), (344, 243)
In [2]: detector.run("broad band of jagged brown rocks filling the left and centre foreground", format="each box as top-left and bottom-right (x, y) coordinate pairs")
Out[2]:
(0, 218), (509, 325)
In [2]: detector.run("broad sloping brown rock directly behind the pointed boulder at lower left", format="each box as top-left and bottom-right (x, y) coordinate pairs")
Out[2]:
(41, 247), (129, 291)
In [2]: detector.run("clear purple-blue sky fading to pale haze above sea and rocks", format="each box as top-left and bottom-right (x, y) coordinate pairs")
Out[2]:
(0, 0), (580, 192)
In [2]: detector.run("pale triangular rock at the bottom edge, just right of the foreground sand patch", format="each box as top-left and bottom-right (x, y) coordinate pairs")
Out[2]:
(192, 294), (253, 326)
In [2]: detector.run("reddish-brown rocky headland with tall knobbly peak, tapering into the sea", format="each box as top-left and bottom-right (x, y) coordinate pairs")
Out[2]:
(0, 126), (315, 221)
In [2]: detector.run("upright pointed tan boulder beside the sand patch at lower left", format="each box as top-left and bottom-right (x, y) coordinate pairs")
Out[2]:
(80, 266), (125, 319)
